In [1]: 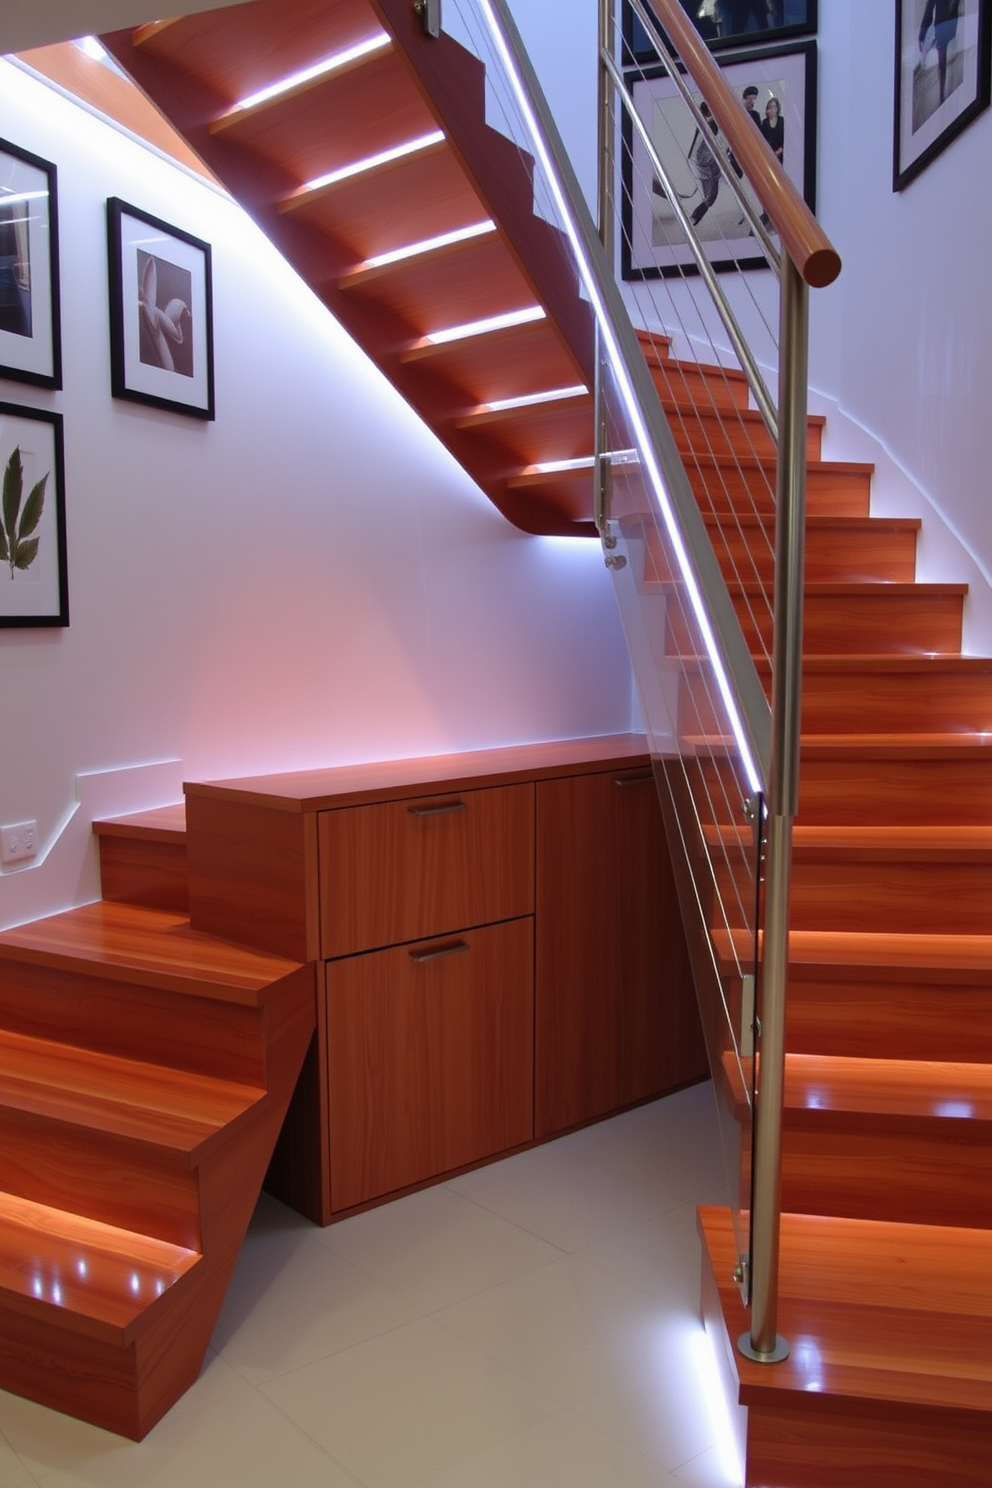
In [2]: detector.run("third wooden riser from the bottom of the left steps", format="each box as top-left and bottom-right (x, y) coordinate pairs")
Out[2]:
(0, 955), (265, 1085)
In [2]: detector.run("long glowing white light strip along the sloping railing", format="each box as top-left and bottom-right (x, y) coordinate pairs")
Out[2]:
(479, 0), (761, 795)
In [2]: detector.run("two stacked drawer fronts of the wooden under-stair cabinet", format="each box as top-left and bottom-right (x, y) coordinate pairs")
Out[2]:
(318, 781), (534, 1213)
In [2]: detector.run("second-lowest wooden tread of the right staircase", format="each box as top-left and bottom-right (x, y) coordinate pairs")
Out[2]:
(785, 1054), (992, 1118)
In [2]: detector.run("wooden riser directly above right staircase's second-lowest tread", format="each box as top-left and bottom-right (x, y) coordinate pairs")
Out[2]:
(787, 982), (992, 1064)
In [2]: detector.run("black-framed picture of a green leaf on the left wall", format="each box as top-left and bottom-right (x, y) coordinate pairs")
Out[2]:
(0, 403), (68, 626)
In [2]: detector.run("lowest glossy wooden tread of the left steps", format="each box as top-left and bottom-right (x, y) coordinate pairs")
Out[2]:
(0, 1192), (201, 1345)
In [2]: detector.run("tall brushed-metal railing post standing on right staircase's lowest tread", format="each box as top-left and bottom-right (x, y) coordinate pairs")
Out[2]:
(738, 254), (809, 1363)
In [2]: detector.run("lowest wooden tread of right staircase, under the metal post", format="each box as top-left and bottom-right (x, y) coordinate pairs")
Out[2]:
(698, 1208), (992, 1412)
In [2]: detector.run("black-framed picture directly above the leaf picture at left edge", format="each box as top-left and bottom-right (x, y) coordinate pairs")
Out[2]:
(0, 140), (62, 387)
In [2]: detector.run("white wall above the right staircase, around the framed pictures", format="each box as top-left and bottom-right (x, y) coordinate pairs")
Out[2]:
(509, 0), (992, 652)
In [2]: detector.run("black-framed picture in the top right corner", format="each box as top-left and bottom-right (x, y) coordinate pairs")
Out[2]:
(892, 0), (992, 190)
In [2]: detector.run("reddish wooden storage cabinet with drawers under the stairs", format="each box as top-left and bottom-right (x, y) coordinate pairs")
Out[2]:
(186, 735), (706, 1225)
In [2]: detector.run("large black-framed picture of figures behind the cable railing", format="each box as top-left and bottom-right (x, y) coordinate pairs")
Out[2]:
(622, 42), (817, 280)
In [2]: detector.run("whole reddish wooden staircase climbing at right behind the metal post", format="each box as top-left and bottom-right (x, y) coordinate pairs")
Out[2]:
(627, 335), (992, 1488)
